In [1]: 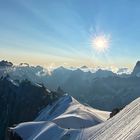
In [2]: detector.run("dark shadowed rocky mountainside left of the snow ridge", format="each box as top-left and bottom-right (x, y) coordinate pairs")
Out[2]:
(0, 78), (61, 140)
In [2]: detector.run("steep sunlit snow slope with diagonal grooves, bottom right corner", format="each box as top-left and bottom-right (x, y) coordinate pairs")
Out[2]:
(86, 98), (140, 140)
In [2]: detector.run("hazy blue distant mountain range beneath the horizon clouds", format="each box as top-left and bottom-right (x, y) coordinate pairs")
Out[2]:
(0, 61), (140, 111)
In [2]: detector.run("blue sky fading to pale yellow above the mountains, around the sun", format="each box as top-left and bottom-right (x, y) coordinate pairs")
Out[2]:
(0, 0), (140, 68)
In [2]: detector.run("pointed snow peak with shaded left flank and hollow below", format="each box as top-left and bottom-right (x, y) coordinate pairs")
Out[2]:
(35, 95), (110, 129)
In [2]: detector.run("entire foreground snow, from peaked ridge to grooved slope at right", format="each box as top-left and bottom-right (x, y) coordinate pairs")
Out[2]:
(11, 95), (140, 140)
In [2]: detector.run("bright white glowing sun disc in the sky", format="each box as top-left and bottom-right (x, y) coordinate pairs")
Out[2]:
(91, 35), (110, 52)
